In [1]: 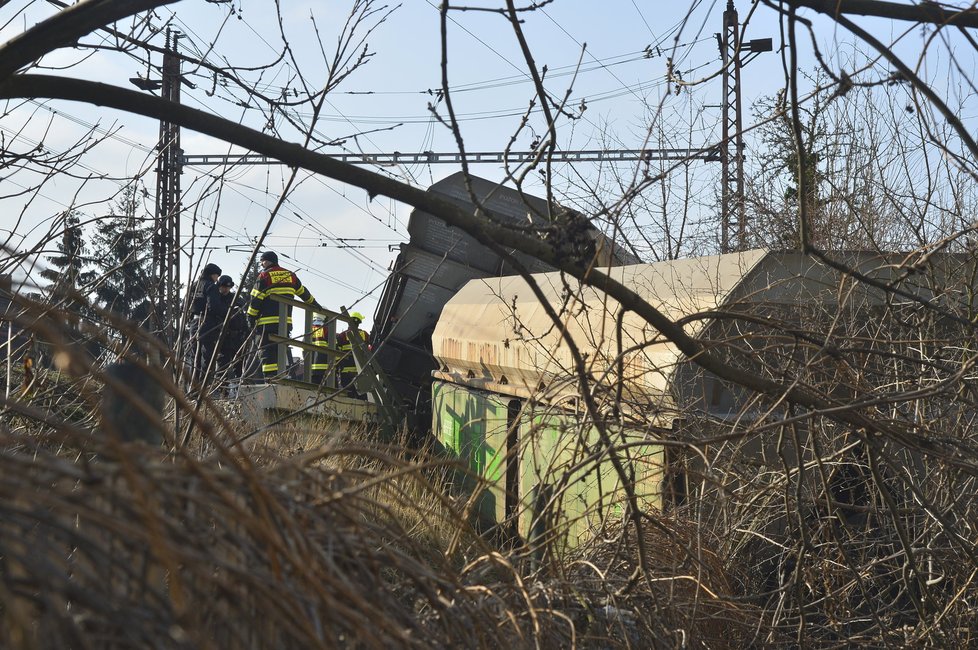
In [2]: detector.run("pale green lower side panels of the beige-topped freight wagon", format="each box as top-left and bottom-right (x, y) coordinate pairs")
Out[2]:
(432, 381), (665, 546)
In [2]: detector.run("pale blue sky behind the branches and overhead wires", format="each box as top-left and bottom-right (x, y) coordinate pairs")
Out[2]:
(0, 0), (972, 327)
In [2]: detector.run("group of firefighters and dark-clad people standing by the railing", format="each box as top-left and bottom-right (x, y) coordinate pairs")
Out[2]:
(191, 251), (368, 397)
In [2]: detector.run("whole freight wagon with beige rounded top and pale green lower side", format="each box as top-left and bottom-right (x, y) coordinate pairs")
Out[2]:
(432, 250), (974, 544)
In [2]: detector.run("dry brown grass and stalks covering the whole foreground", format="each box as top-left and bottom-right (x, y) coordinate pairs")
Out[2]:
(0, 292), (975, 648)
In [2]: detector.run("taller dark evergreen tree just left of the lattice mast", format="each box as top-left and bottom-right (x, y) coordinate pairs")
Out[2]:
(95, 188), (153, 323)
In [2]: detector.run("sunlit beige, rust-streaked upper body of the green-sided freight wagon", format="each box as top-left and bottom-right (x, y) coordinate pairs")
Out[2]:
(432, 250), (768, 410)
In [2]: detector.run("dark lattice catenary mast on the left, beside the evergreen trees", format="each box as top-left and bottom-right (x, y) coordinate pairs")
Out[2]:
(153, 30), (183, 343)
